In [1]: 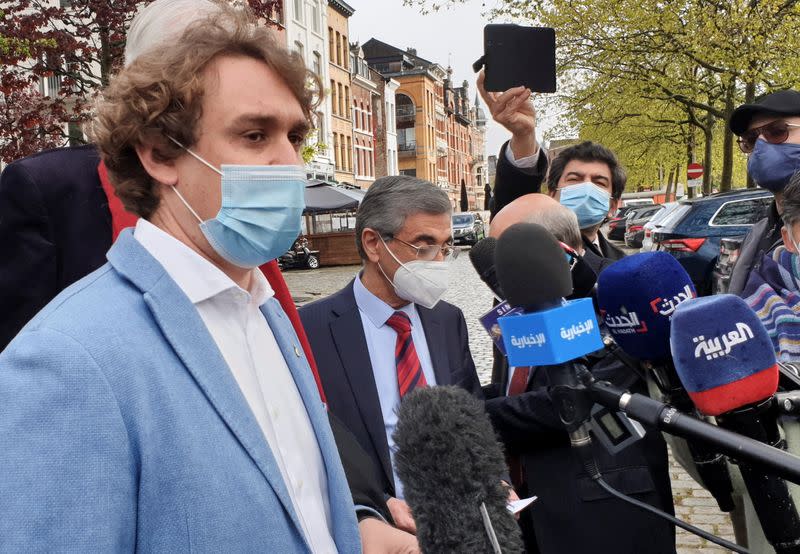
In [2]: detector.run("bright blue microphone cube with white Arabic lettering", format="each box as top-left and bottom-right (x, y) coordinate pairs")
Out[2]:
(497, 298), (603, 366)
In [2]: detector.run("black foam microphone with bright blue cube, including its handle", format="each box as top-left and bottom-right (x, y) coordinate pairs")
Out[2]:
(495, 223), (603, 477)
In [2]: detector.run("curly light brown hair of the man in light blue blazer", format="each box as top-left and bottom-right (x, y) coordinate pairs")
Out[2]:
(89, 5), (322, 219)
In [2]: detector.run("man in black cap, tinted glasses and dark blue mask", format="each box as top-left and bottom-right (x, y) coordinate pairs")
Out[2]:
(728, 90), (800, 294)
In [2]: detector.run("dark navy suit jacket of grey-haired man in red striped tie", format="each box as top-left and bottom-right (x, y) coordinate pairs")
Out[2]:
(300, 281), (482, 496)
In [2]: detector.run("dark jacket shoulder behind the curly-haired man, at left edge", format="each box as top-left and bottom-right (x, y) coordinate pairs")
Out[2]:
(0, 145), (111, 351)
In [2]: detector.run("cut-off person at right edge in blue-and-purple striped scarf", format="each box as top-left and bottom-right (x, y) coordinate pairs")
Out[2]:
(742, 173), (800, 362)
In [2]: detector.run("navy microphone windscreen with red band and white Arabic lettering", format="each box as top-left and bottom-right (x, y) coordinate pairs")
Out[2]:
(671, 294), (778, 416)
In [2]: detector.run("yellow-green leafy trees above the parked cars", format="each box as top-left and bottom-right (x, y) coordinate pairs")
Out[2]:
(405, 0), (800, 191)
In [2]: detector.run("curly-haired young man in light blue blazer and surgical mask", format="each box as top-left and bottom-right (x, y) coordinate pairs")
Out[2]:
(0, 3), (412, 552)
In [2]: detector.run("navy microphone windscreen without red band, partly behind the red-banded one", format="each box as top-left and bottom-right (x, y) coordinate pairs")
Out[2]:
(597, 252), (697, 360)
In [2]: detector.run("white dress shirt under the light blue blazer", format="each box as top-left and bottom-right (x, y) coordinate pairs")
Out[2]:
(133, 219), (336, 554)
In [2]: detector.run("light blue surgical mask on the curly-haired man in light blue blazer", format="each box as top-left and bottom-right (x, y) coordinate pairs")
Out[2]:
(170, 139), (306, 268)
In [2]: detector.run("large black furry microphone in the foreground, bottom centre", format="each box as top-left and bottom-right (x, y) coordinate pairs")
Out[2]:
(394, 386), (524, 554)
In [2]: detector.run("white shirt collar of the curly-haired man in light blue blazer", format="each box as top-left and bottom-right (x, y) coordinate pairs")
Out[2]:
(133, 218), (274, 306)
